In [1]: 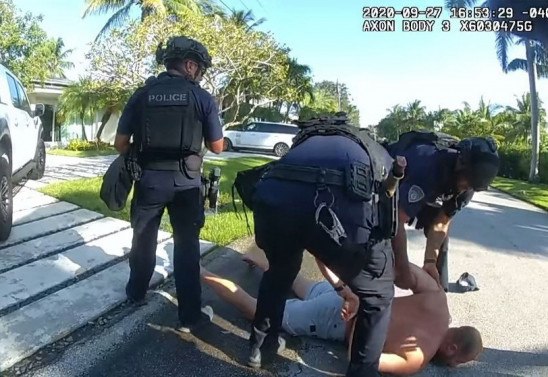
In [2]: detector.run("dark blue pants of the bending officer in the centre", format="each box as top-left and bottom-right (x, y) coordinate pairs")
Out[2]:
(250, 204), (394, 377)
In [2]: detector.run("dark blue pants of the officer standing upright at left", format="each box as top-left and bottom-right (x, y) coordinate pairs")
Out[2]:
(126, 172), (204, 323)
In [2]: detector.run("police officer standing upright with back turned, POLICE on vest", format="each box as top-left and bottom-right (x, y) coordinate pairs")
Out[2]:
(114, 37), (223, 331)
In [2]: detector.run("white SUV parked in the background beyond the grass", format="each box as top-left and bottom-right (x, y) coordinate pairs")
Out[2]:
(224, 122), (299, 157)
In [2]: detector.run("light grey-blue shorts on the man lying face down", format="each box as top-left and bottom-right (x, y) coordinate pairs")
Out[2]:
(282, 281), (346, 342)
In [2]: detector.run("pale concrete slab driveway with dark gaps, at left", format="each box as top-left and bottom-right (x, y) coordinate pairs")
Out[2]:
(0, 156), (214, 372)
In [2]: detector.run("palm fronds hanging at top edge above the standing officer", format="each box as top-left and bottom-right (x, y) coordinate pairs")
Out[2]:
(83, 0), (206, 40)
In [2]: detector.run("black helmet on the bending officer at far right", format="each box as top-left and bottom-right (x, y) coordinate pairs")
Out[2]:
(456, 137), (500, 191)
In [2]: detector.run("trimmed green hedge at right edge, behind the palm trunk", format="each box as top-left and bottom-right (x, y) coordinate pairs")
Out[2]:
(499, 146), (548, 183)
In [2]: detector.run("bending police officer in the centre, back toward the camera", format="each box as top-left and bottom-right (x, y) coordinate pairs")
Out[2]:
(248, 114), (403, 376)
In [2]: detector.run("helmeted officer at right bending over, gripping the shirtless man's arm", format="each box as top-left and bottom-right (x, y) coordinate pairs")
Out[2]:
(388, 132), (499, 289)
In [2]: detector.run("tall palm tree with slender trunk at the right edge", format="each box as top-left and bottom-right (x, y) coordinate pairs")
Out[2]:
(445, 0), (548, 182)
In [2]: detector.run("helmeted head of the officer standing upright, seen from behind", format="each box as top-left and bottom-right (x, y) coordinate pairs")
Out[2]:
(156, 36), (211, 82)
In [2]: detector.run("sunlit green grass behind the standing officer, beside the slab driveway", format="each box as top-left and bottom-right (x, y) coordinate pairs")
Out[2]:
(40, 157), (270, 246)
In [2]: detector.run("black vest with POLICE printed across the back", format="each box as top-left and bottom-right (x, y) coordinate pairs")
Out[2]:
(135, 75), (203, 170)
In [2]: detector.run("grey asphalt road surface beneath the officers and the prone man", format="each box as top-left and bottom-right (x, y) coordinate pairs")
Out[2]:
(29, 191), (548, 377)
